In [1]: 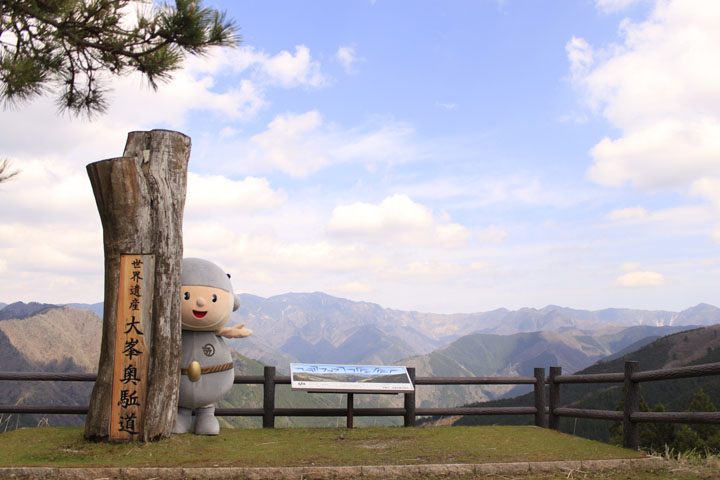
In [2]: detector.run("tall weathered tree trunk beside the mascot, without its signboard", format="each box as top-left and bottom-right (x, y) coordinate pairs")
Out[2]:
(85, 130), (190, 441)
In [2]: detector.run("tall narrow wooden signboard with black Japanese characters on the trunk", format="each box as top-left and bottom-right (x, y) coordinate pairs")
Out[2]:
(110, 254), (155, 440)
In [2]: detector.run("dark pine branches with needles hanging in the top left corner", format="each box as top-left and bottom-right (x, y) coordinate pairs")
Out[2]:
(0, 0), (240, 115)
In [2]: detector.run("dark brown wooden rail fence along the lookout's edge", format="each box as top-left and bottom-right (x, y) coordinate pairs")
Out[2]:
(0, 361), (720, 450)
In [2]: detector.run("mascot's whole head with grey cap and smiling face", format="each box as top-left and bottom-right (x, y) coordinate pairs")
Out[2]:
(180, 258), (240, 331)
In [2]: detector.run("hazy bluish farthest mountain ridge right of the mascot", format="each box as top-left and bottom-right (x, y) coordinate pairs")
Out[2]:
(222, 292), (720, 366)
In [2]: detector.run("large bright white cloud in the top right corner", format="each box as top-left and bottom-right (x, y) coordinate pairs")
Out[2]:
(566, 0), (720, 240)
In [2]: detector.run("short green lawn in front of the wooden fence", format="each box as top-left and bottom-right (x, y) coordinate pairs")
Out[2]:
(0, 426), (644, 467)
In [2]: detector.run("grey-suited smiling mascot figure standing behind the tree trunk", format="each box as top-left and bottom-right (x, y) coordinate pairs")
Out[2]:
(173, 258), (252, 435)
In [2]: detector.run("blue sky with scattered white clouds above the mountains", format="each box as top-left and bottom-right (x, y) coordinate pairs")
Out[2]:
(0, 0), (720, 313)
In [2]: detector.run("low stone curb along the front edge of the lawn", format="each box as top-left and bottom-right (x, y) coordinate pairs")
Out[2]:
(0, 457), (666, 480)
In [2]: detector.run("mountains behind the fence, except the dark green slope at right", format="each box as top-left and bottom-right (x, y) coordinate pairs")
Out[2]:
(0, 293), (720, 430)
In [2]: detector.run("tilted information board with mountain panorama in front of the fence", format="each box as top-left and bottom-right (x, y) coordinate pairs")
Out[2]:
(290, 363), (415, 393)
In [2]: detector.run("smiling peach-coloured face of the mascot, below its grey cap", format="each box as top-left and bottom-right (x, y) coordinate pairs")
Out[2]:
(181, 285), (234, 330)
